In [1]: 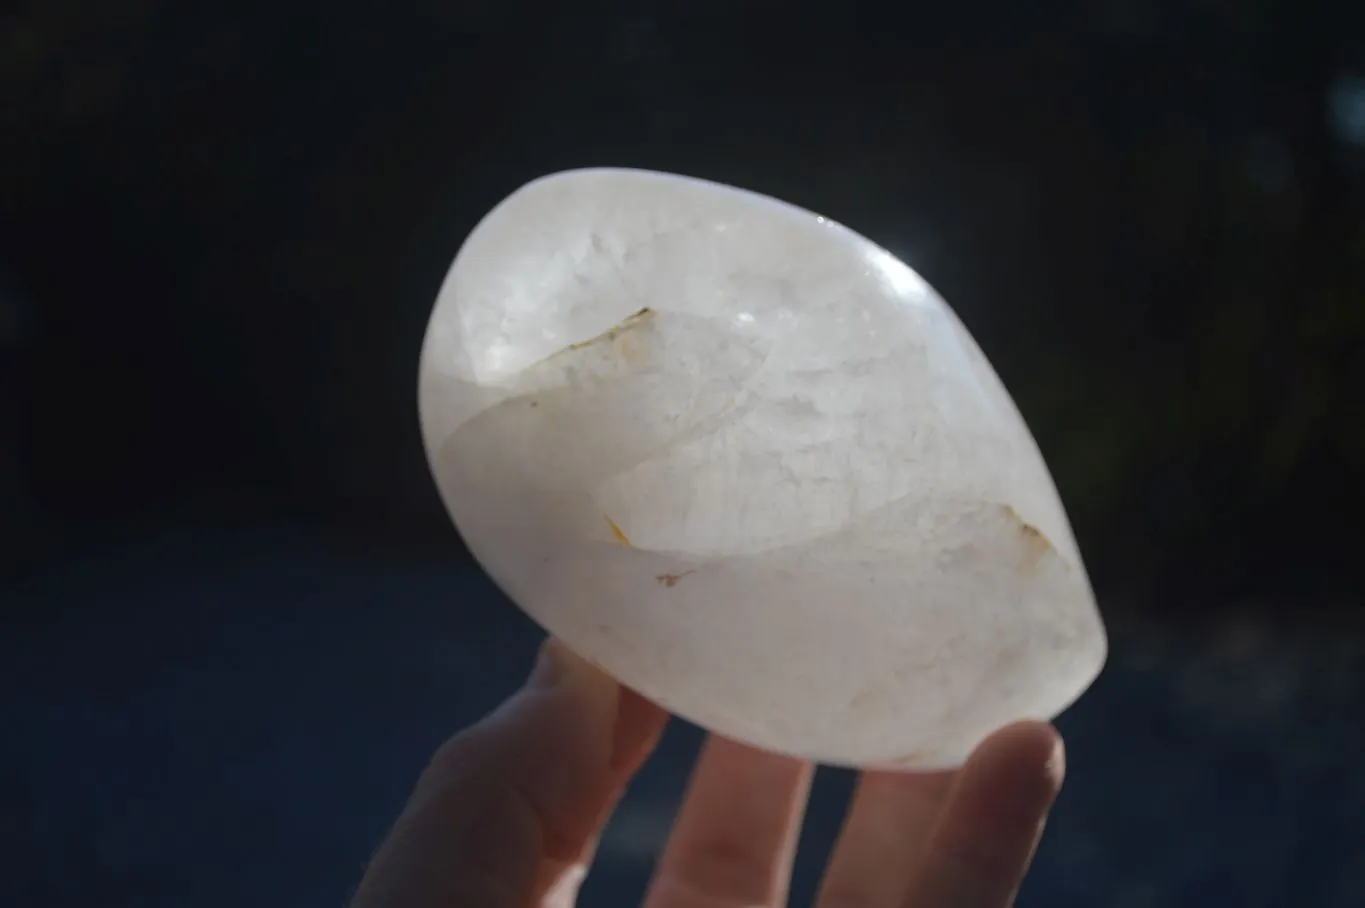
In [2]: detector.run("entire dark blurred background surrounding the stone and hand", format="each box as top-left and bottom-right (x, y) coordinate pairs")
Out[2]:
(0, 0), (1365, 908)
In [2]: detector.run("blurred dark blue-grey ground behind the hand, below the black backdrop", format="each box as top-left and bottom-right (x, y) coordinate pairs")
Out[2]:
(0, 531), (1365, 908)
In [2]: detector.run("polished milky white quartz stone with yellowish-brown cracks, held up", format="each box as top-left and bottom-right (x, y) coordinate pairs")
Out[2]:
(419, 169), (1106, 770)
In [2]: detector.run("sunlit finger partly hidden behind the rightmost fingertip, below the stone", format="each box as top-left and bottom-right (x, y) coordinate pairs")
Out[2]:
(816, 773), (954, 908)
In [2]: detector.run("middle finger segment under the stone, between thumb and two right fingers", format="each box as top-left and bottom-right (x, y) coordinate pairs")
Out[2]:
(646, 736), (815, 908)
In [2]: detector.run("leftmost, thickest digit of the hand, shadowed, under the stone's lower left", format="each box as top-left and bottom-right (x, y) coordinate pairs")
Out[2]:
(352, 642), (665, 908)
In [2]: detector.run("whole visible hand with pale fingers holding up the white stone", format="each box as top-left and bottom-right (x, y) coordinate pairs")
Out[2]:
(352, 640), (1063, 908)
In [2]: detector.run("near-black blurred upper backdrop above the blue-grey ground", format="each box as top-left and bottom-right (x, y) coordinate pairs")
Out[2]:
(0, 0), (1365, 600)
